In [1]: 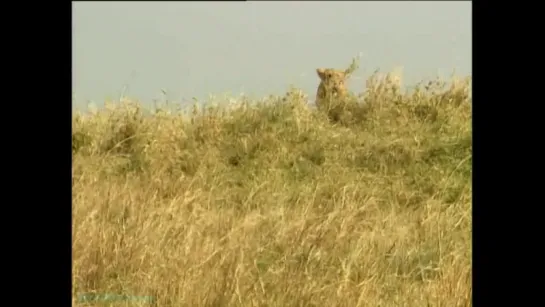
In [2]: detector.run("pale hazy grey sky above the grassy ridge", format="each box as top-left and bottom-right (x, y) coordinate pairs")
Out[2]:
(72, 1), (471, 106)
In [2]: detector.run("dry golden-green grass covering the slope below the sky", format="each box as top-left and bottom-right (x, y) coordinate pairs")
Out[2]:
(72, 68), (472, 307)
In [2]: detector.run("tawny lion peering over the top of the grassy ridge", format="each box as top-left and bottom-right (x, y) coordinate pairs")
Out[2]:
(315, 68), (348, 108)
